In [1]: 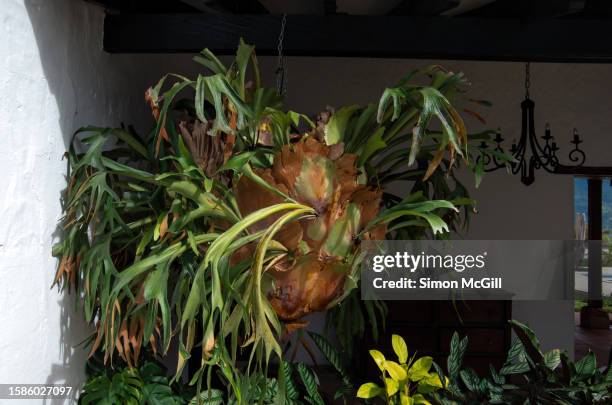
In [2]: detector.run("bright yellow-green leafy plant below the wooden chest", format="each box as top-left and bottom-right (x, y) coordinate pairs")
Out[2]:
(357, 335), (446, 405)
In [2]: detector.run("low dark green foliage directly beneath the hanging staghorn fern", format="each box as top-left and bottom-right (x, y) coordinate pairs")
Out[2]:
(79, 322), (353, 405)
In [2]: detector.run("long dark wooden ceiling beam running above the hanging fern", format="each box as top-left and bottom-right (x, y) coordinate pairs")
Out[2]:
(104, 13), (612, 63)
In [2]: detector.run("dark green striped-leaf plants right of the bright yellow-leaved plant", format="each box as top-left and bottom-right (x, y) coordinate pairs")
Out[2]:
(434, 321), (612, 404)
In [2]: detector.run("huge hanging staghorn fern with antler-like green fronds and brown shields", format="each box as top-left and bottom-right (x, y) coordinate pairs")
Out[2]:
(54, 43), (502, 392)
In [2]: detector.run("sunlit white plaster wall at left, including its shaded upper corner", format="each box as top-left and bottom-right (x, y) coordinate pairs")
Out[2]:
(0, 0), (179, 403)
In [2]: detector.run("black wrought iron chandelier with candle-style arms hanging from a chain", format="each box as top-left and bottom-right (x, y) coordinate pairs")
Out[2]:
(481, 63), (586, 186)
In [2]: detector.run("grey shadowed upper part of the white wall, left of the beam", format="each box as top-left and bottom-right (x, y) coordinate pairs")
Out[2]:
(24, 0), (157, 147)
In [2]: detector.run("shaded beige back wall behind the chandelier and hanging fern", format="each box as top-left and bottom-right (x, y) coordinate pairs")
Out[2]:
(250, 58), (612, 353)
